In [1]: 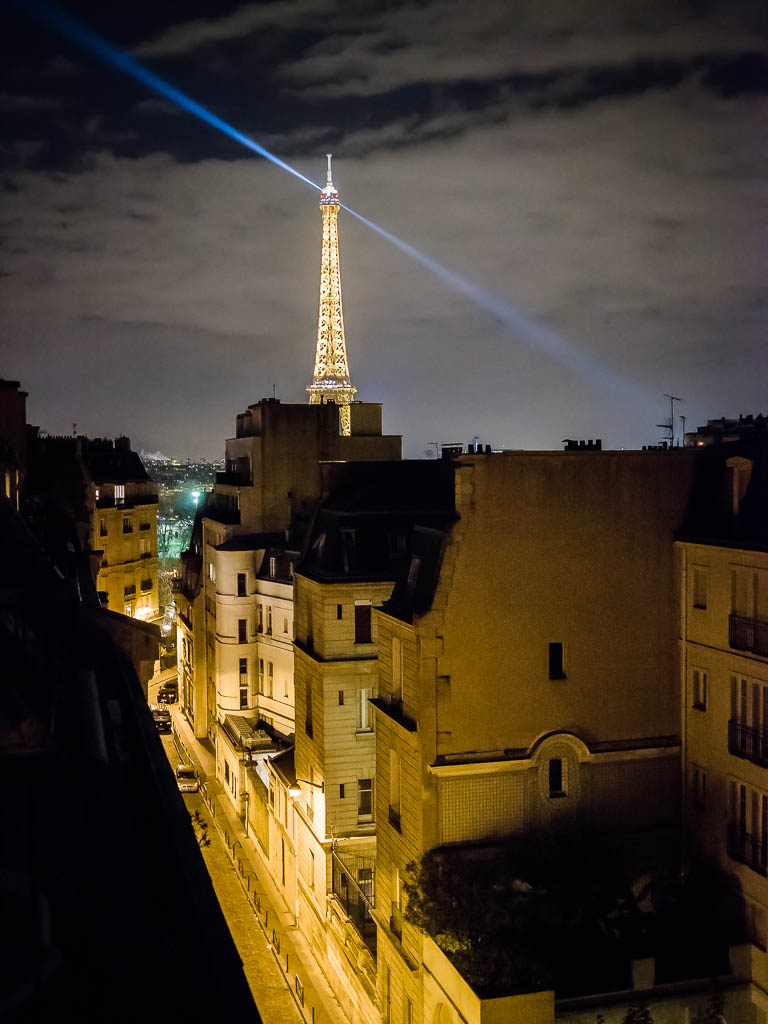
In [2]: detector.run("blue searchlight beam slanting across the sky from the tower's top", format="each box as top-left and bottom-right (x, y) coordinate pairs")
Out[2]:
(16, 0), (644, 401)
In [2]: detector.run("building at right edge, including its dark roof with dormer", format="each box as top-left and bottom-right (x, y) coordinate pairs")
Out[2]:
(677, 442), (768, 999)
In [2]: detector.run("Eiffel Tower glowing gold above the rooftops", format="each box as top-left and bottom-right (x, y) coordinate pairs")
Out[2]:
(307, 153), (357, 436)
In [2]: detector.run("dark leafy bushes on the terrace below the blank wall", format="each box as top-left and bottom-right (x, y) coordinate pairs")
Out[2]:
(404, 822), (740, 999)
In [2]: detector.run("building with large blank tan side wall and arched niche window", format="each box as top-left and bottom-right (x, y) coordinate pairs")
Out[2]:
(373, 450), (712, 1024)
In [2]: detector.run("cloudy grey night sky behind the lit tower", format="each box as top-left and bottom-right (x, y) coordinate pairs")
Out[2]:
(0, 0), (768, 458)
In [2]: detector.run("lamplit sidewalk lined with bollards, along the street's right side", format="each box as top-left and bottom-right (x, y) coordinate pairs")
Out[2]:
(171, 705), (349, 1024)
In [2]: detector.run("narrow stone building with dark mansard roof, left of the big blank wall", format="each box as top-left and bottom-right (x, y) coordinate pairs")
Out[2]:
(288, 463), (454, 1022)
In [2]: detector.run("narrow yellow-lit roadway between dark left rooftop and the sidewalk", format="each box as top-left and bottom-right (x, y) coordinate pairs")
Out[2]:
(161, 735), (302, 1024)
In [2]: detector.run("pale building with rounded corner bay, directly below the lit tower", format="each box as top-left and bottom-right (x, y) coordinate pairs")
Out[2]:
(177, 398), (400, 790)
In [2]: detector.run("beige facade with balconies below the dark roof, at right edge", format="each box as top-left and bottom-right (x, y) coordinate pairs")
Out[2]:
(678, 543), (768, 962)
